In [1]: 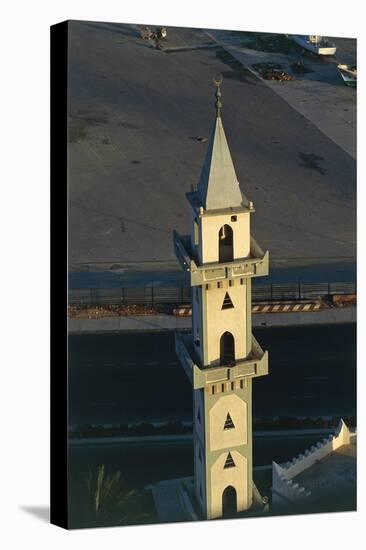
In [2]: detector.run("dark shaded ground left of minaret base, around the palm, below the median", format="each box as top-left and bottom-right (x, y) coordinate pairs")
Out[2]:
(69, 442), (193, 528)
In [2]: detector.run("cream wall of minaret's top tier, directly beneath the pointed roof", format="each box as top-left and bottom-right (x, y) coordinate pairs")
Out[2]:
(199, 212), (250, 264)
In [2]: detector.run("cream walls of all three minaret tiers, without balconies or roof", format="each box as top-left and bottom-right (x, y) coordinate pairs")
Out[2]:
(187, 198), (252, 518)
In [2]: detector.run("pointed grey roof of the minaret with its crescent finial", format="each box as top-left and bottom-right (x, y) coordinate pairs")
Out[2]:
(197, 77), (248, 210)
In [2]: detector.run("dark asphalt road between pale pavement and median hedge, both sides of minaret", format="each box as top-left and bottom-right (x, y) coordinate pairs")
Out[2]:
(69, 324), (356, 425)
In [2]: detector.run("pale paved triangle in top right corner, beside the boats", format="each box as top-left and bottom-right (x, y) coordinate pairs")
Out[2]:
(207, 30), (357, 159)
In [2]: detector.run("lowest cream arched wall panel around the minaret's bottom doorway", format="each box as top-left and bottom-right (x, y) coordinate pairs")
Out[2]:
(208, 450), (251, 519)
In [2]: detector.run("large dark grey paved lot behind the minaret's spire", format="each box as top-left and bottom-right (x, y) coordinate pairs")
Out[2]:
(69, 22), (356, 271)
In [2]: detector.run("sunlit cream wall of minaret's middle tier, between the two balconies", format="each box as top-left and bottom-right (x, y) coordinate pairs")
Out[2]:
(202, 279), (248, 365)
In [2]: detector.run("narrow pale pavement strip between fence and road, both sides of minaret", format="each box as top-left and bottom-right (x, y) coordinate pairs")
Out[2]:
(68, 306), (356, 334)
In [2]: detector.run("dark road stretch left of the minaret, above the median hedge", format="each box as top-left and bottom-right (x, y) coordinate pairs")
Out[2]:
(69, 333), (192, 425)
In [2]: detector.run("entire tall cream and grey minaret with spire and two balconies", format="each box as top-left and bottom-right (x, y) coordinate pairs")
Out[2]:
(174, 77), (268, 519)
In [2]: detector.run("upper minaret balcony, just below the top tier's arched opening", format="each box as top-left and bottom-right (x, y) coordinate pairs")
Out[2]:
(174, 231), (269, 286)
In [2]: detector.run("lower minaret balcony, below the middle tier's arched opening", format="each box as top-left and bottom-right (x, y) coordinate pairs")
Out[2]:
(175, 331), (268, 390)
